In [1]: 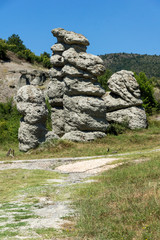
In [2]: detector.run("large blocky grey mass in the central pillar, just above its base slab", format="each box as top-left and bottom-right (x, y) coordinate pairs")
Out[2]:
(64, 95), (108, 132)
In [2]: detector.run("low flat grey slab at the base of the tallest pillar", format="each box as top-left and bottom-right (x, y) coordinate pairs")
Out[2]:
(62, 131), (106, 142)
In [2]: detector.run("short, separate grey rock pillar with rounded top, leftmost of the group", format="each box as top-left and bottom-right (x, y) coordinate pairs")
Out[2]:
(16, 85), (48, 152)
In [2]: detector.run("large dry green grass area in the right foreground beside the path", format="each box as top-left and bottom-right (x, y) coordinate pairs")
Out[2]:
(73, 154), (160, 240)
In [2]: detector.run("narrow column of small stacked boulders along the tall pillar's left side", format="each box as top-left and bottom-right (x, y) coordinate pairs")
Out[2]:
(47, 40), (65, 137)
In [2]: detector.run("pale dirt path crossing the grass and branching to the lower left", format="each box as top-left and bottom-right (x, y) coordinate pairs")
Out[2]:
(0, 149), (160, 240)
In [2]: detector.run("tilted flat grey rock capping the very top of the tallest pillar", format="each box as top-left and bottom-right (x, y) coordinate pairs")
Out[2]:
(52, 28), (89, 46)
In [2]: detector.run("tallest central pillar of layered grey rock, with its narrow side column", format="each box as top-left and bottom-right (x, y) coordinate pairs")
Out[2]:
(48, 28), (108, 141)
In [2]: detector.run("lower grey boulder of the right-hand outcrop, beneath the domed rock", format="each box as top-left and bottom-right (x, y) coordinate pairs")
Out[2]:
(106, 107), (147, 129)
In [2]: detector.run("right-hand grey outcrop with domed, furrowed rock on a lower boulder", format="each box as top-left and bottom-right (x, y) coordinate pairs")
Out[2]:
(103, 70), (147, 129)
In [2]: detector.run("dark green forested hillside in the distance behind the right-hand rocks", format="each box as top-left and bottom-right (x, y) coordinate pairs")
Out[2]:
(100, 53), (160, 79)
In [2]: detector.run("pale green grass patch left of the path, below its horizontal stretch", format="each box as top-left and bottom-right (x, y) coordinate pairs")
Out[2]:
(0, 169), (60, 203)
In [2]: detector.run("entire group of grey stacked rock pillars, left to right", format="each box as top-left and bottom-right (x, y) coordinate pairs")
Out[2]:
(16, 28), (147, 151)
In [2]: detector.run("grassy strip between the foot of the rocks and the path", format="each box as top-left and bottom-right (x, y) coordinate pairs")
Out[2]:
(0, 116), (160, 160)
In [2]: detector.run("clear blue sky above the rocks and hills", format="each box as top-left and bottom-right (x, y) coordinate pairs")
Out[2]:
(0, 0), (160, 55)
